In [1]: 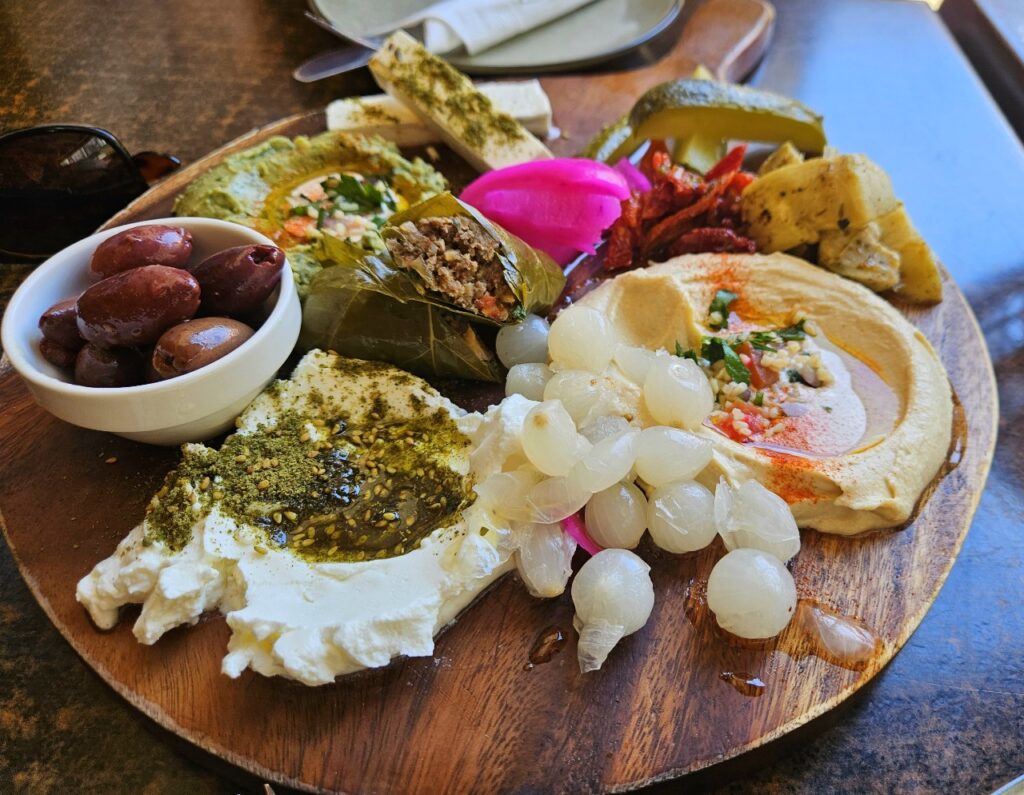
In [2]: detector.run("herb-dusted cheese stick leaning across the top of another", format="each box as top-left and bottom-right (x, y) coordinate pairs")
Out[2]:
(370, 31), (554, 171)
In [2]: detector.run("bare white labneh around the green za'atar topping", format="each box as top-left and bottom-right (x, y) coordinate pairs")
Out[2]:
(77, 351), (514, 684)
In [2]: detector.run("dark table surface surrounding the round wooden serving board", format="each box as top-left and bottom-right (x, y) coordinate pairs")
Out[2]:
(0, 0), (1024, 794)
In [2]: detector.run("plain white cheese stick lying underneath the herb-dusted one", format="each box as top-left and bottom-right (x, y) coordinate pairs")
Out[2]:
(327, 80), (551, 147)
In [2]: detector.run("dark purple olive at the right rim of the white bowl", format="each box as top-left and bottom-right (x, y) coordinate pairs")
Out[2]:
(188, 246), (285, 315)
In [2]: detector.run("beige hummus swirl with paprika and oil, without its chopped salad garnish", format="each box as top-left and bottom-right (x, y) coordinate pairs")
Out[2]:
(581, 254), (952, 535)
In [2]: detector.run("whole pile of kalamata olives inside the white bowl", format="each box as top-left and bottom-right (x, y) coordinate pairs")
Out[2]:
(39, 224), (285, 386)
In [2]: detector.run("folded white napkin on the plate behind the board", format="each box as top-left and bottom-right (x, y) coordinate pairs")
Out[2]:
(370, 0), (593, 55)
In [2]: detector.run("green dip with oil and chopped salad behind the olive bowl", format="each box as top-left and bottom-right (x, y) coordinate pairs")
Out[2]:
(174, 132), (445, 297)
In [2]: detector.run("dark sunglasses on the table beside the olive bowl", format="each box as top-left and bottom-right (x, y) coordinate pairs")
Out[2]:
(0, 124), (181, 260)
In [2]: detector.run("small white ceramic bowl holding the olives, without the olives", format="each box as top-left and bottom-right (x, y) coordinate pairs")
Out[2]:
(2, 218), (302, 445)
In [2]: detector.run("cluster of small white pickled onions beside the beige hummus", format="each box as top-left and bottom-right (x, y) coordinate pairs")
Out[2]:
(476, 305), (800, 672)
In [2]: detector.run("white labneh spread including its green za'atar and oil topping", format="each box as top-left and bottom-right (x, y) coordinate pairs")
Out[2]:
(76, 350), (514, 685)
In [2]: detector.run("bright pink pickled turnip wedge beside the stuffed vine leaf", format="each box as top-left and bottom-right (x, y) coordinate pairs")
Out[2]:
(459, 158), (630, 264)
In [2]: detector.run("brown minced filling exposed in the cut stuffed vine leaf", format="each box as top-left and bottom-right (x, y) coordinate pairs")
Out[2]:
(387, 217), (516, 322)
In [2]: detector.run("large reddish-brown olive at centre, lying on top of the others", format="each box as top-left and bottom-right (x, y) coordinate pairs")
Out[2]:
(78, 265), (200, 347)
